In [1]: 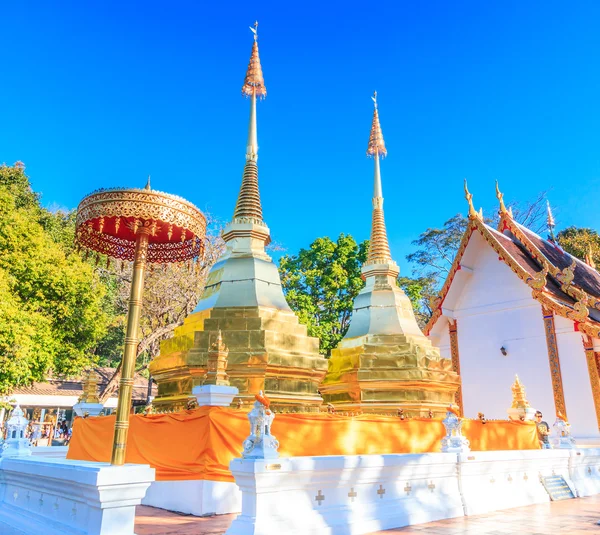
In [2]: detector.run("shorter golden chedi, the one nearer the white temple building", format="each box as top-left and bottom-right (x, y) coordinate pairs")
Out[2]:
(319, 93), (459, 416)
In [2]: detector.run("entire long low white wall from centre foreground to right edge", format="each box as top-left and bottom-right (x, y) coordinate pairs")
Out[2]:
(226, 449), (600, 535)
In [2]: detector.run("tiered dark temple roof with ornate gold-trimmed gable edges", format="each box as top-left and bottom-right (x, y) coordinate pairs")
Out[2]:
(424, 205), (600, 337)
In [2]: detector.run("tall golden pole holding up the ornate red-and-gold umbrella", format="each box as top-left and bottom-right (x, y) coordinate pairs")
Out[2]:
(110, 227), (149, 466)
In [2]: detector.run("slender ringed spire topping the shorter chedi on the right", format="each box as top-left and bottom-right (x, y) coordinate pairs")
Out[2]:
(365, 91), (393, 265)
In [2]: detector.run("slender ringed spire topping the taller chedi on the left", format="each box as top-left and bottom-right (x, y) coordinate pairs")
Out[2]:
(233, 22), (267, 224)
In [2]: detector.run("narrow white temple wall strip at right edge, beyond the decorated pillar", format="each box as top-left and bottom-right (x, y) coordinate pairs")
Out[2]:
(545, 316), (600, 437)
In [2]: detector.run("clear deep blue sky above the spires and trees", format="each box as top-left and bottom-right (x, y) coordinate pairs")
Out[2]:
(0, 0), (600, 274)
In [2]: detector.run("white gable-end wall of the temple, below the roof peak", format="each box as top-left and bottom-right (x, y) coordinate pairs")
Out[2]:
(440, 235), (554, 419)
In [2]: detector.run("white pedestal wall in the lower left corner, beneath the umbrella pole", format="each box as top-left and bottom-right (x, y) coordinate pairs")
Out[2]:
(0, 457), (154, 535)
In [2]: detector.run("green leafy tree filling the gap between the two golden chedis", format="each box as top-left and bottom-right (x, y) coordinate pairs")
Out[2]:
(279, 234), (369, 355)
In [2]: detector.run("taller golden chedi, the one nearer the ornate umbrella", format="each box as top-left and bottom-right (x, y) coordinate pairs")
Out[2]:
(150, 23), (327, 411)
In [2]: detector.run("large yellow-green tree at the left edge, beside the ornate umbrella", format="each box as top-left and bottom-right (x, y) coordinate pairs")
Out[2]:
(0, 164), (108, 393)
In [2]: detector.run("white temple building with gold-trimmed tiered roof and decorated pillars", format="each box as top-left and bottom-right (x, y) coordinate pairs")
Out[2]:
(425, 184), (600, 439)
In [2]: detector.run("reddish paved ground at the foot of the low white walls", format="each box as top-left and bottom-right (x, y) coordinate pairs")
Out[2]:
(135, 495), (600, 535)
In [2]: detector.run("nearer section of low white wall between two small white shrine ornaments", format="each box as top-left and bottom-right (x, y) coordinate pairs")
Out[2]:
(227, 453), (464, 535)
